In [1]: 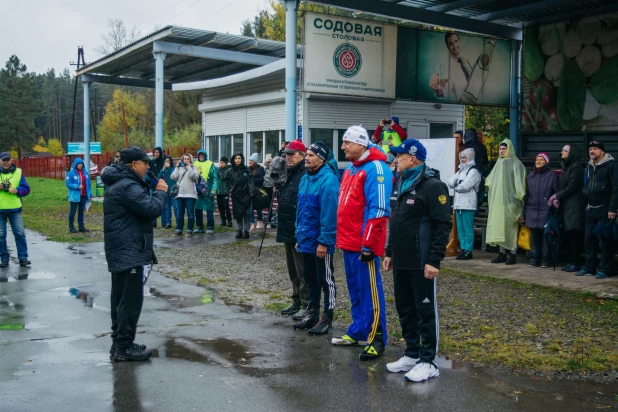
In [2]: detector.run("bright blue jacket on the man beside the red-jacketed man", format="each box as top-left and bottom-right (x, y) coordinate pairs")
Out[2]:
(296, 164), (339, 254)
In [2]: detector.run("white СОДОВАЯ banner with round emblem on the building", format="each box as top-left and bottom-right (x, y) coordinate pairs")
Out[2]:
(304, 13), (397, 98)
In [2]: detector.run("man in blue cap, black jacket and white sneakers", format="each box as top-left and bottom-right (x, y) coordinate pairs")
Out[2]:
(383, 139), (451, 382)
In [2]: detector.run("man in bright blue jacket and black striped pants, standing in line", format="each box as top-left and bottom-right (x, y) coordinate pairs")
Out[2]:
(294, 142), (339, 335)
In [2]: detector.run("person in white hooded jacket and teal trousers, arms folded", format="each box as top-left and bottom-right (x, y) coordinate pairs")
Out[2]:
(447, 149), (481, 260)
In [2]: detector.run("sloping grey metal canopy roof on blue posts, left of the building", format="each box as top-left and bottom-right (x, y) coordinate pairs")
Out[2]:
(77, 26), (301, 83)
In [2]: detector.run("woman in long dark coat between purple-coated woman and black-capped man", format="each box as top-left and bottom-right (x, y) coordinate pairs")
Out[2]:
(556, 145), (586, 272)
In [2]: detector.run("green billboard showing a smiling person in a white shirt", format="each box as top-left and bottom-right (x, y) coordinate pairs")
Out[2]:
(396, 27), (511, 106)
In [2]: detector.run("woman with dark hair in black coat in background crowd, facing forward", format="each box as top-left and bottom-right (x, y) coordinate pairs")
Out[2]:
(225, 153), (255, 239)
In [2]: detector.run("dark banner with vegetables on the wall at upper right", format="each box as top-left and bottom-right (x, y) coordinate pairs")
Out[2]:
(521, 13), (618, 133)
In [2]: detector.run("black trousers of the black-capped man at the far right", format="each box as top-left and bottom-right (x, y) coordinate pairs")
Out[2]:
(585, 205), (614, 275)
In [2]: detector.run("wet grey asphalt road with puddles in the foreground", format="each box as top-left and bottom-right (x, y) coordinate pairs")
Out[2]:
(0, 232), (618, 412)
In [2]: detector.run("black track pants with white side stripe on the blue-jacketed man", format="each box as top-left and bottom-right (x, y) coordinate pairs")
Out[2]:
(303, 253), (337, 313)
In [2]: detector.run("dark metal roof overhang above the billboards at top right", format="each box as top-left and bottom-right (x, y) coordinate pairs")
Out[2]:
(311, 0), (618, 40)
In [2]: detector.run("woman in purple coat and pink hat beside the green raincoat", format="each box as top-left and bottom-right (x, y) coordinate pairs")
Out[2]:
(520, 153), (558, 268)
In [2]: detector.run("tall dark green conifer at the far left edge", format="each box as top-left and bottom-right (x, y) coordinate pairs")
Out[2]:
(0, 55), (40, 158)
